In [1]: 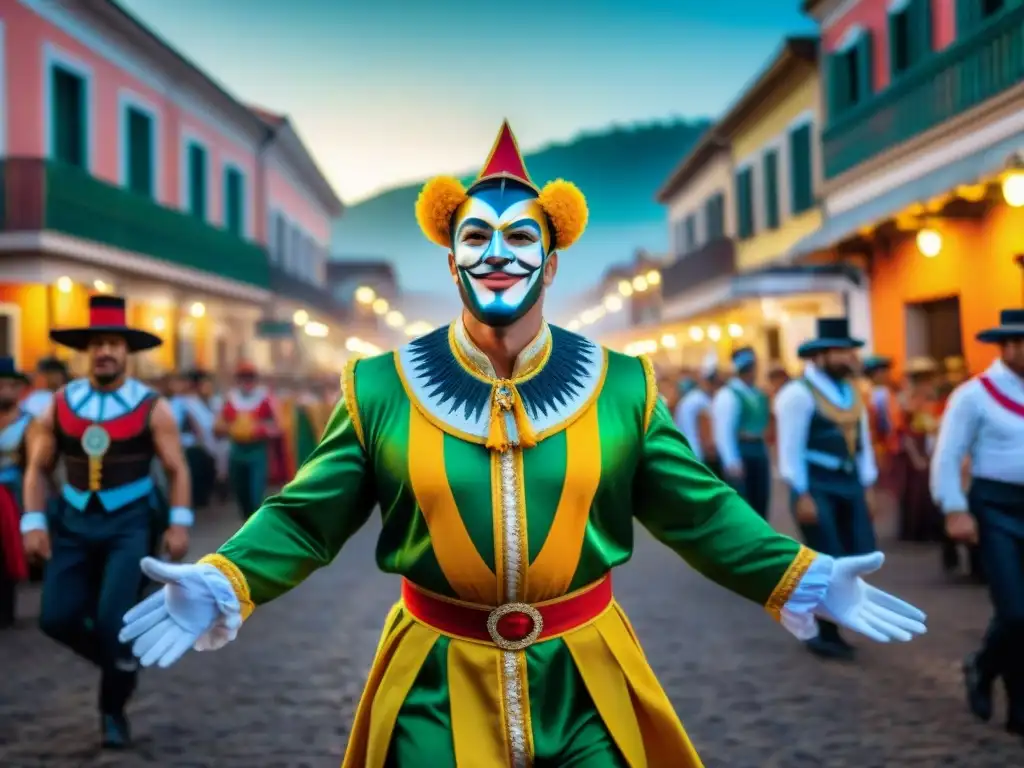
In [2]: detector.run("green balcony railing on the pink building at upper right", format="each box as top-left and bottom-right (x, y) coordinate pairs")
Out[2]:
(822, 5), (1024, 178)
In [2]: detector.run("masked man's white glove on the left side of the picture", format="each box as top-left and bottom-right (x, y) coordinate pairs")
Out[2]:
(119, 557), (242, 667)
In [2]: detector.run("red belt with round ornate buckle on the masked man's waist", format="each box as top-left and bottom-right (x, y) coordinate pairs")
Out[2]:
(401, 573), (611, 650)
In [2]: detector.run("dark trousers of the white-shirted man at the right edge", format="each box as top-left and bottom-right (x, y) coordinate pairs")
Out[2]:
(969, 478), (1024, 722)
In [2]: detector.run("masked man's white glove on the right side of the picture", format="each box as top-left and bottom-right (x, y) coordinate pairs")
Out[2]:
(814, 552), (927, 643)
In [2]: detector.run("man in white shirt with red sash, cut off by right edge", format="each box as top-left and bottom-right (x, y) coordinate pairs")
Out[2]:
(931, 309), (1024, 735)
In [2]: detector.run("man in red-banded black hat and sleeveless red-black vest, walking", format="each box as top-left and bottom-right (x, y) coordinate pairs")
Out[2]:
(22, 296), (193, 749)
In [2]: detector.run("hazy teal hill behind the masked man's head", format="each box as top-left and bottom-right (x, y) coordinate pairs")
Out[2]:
(332, 120), (710, 303)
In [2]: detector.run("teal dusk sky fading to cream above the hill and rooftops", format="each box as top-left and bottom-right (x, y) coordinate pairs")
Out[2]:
(119, 0), (814, 204)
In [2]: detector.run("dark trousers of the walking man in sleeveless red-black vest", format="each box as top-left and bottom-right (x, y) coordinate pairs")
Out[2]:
(39, 498), (153, 714)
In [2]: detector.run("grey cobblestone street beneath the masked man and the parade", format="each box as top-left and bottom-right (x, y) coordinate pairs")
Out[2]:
(0, 495), (1024, 768)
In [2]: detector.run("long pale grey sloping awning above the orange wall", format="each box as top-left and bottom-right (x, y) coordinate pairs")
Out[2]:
(782, 124), (1024, 262)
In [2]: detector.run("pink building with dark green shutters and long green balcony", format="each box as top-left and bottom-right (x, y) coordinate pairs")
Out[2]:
(0, 0), (342, 373)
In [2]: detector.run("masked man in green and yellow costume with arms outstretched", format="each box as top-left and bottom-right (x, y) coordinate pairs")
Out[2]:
(123, 124), (924, 768)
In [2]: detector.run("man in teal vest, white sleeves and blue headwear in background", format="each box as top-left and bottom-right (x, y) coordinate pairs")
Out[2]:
(712, 347), (771, 520)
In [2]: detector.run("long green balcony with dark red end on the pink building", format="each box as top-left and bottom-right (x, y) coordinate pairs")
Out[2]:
(0, 158), (270, 288)
